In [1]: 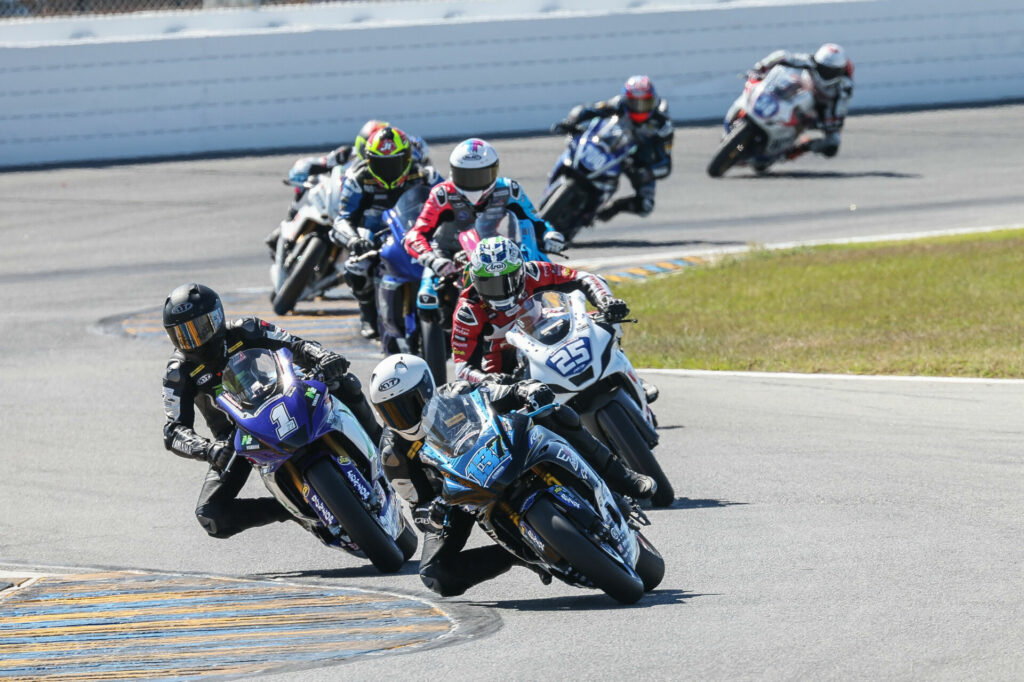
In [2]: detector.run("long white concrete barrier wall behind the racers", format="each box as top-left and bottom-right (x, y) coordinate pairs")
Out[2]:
(0, 0), (1024, 167)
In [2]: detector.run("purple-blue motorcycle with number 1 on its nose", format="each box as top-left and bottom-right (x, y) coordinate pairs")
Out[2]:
(217, 348), (417, 573)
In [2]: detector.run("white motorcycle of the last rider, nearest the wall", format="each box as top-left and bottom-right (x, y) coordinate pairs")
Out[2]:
(708, 65), (816, 177)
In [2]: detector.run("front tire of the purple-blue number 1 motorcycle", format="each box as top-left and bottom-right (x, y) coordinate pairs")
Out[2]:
(306, 457), (405, 573)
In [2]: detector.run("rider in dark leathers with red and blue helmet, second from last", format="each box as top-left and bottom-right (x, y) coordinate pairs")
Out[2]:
(548, 76), (675, 220)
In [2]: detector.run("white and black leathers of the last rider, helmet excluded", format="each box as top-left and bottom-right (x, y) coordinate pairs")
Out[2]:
(754, 50), (853, 159)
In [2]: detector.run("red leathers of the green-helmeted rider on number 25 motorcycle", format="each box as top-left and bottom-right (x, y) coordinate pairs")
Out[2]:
(452, 261), (616, 382)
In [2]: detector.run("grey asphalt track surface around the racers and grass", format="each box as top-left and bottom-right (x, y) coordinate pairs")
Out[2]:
(0, 106), (1024, 680)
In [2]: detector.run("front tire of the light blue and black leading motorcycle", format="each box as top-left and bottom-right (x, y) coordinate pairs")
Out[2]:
(526, 497), (644, 604)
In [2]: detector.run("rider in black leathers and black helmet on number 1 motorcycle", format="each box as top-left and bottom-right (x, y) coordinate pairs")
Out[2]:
(163, 283), (381, 538)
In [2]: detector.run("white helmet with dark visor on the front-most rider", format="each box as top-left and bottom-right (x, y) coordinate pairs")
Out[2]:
(370, 353), (434, 440)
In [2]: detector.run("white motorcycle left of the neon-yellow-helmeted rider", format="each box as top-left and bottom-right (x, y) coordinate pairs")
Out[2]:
(270, 166), (345, 315)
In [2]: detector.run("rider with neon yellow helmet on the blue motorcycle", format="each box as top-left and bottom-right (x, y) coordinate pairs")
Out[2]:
(331, 126), (441, 339)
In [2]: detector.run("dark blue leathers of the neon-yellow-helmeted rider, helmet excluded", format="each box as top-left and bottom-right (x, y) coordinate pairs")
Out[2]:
(331, 160), (442, 338)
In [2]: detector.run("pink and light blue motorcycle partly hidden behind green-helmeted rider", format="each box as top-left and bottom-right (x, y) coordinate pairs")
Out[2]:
(417, 209), (551, 384)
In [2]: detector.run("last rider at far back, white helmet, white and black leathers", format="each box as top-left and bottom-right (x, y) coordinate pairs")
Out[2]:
(752, 43), (853, 159)
